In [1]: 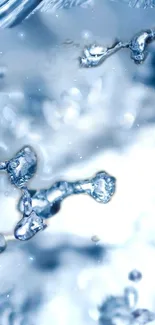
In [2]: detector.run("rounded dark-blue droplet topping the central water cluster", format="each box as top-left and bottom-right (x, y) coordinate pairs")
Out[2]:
(7, 146), (37, 187)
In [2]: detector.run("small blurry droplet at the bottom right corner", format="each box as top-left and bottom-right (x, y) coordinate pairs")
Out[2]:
(132, 308), (155, 325)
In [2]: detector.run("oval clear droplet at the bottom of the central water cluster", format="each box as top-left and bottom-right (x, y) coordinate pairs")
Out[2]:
(14, 211), (46, 241)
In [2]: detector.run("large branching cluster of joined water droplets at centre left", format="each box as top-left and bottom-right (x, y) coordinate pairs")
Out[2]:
(0, 146), (116, 241)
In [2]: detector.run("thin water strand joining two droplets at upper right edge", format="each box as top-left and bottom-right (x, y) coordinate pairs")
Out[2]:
(79, 29), (155, 68)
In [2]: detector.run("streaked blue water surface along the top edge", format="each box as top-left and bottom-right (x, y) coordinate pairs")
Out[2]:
(0, 0), (155, 28)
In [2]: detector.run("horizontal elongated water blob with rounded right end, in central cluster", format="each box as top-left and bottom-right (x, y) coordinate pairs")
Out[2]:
(18, 168), (116, 224)
